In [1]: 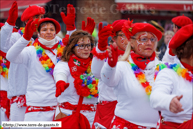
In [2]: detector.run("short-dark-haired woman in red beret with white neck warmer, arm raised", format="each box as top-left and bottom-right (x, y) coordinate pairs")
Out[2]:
(6, 18), (64, 121)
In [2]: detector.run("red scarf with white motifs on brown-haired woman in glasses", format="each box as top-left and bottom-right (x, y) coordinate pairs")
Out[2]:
(68, 55), (92, 97)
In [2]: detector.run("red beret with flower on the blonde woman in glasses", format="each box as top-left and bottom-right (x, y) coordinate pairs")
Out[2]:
(122, 19), (162, 41)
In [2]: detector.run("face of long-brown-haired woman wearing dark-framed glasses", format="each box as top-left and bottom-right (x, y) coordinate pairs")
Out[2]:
(74, 37), (91, 59)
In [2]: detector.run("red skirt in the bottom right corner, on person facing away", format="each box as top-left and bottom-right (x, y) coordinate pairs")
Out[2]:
(159, 115), (193, 129)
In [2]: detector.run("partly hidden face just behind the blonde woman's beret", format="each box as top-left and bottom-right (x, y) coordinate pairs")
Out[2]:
(113, 31), (128, 51)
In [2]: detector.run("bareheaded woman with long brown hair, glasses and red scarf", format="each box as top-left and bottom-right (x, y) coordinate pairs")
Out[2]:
(54, 30), (98, 126)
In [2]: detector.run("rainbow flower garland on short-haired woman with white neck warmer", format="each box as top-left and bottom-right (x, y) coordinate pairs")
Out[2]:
(33, 41), (64, 76)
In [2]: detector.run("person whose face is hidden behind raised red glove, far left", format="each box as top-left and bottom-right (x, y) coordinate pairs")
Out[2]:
(1, 2), (45, 121)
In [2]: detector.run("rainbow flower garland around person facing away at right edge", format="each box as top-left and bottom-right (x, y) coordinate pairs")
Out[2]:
(154, 63), (193, 82)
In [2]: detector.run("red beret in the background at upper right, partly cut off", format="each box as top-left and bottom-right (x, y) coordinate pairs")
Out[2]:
(172, 15), (192, 27)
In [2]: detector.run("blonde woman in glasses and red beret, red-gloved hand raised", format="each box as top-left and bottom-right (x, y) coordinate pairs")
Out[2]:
(101, 20), (162, 129)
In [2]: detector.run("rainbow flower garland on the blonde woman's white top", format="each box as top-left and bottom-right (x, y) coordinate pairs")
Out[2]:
(128, 61), (152, 96)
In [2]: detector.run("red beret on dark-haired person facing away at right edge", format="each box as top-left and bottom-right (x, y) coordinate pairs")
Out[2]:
(169, 24), (193, 49)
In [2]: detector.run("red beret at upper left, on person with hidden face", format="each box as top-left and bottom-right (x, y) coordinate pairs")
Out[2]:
(21, 5), (45, 22)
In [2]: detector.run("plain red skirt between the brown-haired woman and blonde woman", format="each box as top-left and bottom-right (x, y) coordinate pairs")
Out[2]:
(92, 101), (117, 129)
